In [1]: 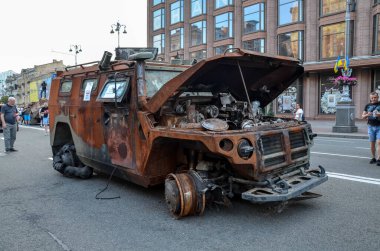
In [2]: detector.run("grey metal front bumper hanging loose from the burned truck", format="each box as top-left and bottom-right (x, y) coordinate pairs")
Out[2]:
(241, 170), (328, 203)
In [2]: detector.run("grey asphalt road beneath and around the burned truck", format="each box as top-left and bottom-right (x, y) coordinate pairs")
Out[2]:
(0, 127), (380, 250)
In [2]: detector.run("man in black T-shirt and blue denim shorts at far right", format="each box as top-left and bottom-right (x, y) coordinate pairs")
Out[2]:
(362, 92), (380, 166)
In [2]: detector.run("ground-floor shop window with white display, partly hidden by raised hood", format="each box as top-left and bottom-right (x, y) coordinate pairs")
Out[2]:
(276, 80), (303, 114)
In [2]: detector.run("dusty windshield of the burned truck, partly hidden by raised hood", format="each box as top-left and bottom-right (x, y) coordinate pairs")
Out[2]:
(145, 70), (181, 98)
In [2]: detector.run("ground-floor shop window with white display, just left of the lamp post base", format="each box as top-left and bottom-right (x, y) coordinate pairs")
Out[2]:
(319, 75), (352, 114)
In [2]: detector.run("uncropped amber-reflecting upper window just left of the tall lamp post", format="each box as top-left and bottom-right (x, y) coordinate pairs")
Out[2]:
(320, 22), (346, 59)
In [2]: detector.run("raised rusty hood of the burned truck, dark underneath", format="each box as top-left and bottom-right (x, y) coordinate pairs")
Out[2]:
(145, 49), (303, 113)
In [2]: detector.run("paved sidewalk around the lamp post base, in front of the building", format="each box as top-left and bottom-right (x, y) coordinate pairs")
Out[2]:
(307, 120), (368, 139)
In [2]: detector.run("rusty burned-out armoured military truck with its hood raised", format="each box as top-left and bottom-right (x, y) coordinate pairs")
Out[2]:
(49, 48), (328, 217)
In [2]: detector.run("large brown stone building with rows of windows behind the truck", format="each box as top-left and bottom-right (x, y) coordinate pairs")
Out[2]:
(148, 0), (380, 119)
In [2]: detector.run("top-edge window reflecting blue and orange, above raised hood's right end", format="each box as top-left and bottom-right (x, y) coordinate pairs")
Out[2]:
(278, 0), (303, 25)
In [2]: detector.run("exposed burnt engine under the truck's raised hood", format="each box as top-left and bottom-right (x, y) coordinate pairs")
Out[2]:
(162, 92), (285, 131)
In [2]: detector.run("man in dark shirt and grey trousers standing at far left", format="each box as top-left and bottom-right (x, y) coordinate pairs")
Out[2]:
(1, 97), (19, 153)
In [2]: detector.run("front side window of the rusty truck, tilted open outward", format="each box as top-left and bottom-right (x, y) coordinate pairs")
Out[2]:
(96, 77), (130, 102)
